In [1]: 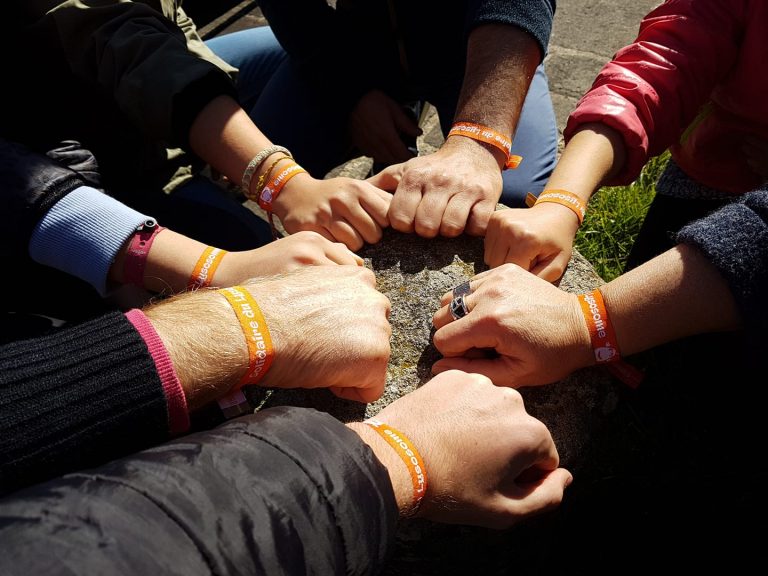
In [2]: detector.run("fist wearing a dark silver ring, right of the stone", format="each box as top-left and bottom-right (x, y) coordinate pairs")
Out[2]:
(432, 264), (595, 388)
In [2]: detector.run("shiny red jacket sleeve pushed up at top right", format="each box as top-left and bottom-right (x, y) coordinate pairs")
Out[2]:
(564, 0), (745, 185)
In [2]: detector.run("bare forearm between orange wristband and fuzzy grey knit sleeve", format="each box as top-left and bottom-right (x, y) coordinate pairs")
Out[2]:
(600, 245), (742, 355)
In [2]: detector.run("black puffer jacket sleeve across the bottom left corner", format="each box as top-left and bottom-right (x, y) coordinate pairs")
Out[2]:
(0, 408), (397, 576)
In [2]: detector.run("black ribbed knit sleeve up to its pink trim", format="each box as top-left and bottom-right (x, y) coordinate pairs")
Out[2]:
(0, 312), (169, 494)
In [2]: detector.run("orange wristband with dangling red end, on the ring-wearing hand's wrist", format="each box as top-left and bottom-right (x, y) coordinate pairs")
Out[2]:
(578, 289), (645, 388)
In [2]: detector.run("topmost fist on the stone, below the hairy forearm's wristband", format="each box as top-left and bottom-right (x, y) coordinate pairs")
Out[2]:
(368, 137), (502, 238)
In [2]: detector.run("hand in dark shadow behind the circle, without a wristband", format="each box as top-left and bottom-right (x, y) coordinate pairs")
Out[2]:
(348, 90), (421, 164)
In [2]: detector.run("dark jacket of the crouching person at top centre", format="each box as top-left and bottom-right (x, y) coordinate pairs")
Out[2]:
(259, 0), (556, 106)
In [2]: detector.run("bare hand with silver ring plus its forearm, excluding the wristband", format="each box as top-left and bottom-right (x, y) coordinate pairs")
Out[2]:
(432, 245), (742, 388)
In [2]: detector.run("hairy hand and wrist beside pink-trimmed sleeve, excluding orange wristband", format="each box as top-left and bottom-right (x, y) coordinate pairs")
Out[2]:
(145, 265), (391, 410)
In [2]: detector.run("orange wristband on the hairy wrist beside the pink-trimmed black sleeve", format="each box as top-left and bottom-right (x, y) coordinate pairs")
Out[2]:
(218, 286), (275, 394)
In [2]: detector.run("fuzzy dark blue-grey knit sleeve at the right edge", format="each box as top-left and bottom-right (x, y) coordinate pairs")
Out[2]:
(677, 190), (768, 350)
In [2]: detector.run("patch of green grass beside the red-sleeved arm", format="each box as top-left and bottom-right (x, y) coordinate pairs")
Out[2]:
(574, 152), (669, 282)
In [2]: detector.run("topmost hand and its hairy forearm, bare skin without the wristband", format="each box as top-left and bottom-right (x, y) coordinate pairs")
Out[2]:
(368, 24), (541, 238)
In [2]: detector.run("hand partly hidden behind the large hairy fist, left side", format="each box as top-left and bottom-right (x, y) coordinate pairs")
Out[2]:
(215, 231), (363, 286)
